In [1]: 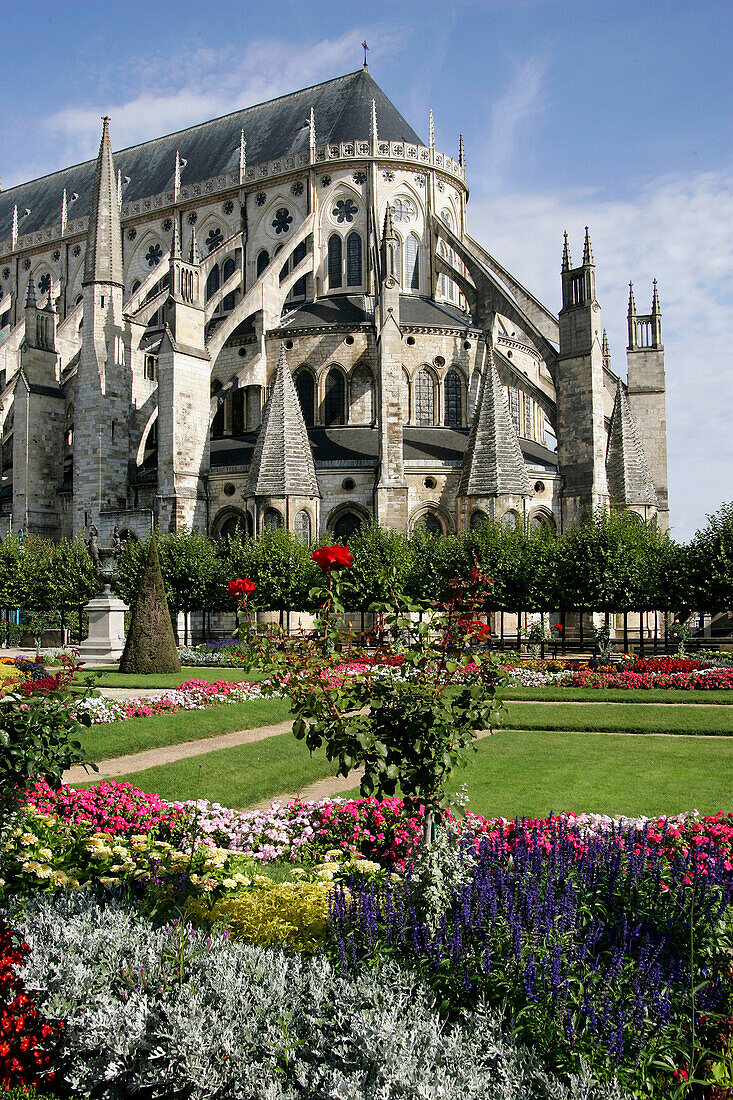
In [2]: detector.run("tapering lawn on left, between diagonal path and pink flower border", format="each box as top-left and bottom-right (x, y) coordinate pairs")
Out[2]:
(75, 734), (336, 810)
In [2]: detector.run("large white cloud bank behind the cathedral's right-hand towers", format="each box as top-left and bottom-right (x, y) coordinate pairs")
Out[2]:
(469, 173), (733, 538)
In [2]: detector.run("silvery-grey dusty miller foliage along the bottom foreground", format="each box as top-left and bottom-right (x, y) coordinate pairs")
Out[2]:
(2, 894), (621, 1100)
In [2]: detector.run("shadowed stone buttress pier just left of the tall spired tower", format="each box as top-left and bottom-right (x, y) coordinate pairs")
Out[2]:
(13, 275), (65, 538)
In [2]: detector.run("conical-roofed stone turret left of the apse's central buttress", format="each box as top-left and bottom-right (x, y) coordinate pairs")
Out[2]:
(244, 347), (320, 543)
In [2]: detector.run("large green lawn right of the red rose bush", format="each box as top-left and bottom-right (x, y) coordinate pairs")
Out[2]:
(448, 729), (733, 817)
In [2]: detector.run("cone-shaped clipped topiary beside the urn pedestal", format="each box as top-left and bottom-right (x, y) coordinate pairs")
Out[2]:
(120, 538), (180, 672)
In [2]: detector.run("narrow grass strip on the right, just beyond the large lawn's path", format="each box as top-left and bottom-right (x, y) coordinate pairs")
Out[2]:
(503, 702), (733, 736)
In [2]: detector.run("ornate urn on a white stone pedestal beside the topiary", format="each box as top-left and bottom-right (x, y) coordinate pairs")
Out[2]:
(79, 524), (130, 669)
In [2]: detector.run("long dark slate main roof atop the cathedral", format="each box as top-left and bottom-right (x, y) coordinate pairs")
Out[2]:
(0, 69), (423, 240)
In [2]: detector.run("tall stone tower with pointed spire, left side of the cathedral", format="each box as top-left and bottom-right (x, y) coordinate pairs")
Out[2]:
(74, 118), (131, 538)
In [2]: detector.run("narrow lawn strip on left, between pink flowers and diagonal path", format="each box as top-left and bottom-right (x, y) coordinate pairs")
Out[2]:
(74, 699), (291, 763)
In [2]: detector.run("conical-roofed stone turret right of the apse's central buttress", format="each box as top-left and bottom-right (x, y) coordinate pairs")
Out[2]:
(456, 343), (532, 534)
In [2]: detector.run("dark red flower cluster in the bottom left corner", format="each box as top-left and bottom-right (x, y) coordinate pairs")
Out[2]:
(0, 920), (64, 1092)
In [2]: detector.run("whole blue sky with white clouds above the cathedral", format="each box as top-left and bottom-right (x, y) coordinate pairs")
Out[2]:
(0, 0), (733, 538)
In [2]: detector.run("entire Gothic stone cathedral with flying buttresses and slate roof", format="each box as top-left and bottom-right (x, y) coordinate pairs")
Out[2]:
(0, 69), (668, 539)
